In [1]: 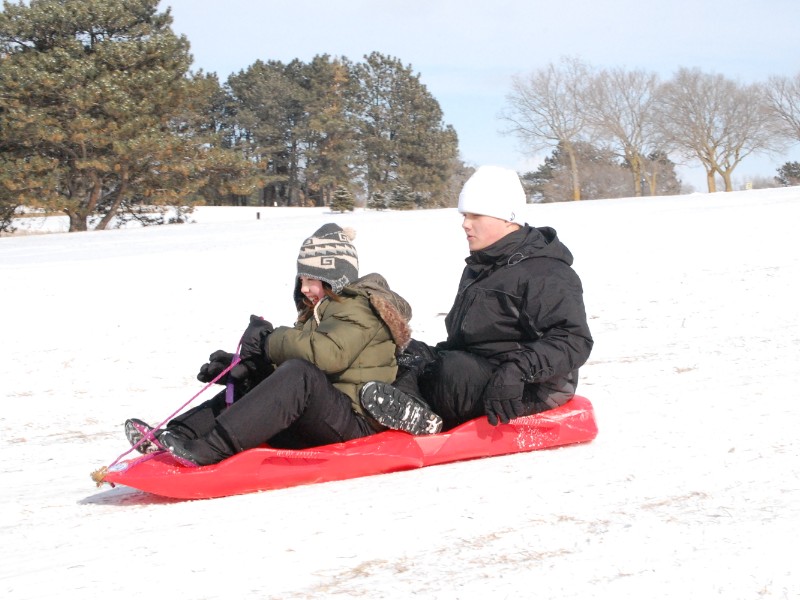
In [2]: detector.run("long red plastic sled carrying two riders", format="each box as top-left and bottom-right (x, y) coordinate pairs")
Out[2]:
(103, 396), (597, 499)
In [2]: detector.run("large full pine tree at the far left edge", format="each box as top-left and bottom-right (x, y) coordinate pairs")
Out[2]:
(0, 0), (253, 231)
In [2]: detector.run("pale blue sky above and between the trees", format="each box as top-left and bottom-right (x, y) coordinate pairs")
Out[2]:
(160, 0), (800, 191)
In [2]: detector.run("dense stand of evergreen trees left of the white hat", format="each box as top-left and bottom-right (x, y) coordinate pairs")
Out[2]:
(0, 0), (460, 231)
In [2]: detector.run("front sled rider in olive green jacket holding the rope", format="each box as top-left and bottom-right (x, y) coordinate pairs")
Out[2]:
(125, 223), (441, 465)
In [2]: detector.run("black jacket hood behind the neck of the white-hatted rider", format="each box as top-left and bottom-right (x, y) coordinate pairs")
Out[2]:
(466, 224), (573, 266)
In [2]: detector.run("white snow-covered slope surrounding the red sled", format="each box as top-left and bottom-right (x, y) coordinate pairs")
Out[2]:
(0, 188), (800, 600)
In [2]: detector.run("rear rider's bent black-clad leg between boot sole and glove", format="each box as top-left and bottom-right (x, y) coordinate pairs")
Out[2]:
(419, 350), (495, 429)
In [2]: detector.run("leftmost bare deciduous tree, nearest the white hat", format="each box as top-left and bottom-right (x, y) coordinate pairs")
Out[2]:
(501, 57), (590, 200)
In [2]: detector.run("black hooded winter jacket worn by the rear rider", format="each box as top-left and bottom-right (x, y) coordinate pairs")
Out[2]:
(438, 225), (593, 409)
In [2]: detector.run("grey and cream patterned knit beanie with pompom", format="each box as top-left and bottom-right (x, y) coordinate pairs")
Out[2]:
(297, 223), (358, 294)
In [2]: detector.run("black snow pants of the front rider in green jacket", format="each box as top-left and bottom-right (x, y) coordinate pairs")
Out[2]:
(167, 359), (375, 454)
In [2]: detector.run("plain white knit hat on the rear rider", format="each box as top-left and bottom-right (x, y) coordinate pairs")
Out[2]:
(458, 166), (527, 223)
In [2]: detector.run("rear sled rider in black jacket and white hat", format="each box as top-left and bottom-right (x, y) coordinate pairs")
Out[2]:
(361, 166), (593, 433)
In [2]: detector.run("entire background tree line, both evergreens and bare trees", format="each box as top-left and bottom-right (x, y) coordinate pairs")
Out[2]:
(0, 0), (800, 231)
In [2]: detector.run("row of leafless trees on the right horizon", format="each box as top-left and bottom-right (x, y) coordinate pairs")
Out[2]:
(502, 57), (800, 200)
